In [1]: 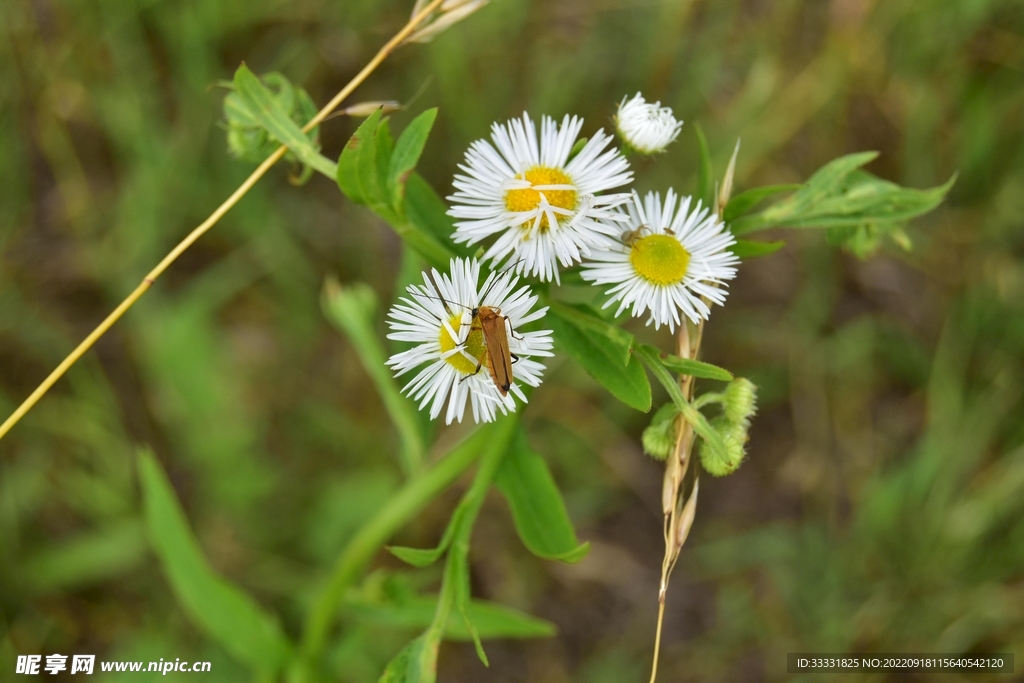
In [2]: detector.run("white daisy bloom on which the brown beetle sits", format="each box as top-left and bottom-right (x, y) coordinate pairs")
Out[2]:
(387, 258), (552, 424)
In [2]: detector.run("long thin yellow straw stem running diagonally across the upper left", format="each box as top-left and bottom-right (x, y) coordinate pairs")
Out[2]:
(0, 0), (443, 439)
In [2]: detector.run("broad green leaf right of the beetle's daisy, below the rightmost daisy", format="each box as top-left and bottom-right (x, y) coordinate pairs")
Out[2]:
(545, 305), (651, 413)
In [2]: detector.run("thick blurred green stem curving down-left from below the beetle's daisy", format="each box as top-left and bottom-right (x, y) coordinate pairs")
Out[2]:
(291, 428), (494, 681)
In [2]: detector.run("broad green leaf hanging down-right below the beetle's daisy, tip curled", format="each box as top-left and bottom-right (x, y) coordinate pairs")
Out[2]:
(495, 429), (590, 564)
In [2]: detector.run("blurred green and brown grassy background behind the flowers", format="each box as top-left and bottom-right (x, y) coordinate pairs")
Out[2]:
(0, 0), (1024, 683)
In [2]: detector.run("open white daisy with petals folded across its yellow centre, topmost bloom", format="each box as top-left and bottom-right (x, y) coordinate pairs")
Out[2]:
(449, 114), (633, 282)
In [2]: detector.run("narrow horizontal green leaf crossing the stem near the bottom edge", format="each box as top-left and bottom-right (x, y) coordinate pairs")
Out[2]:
(344, 595), (556, 642)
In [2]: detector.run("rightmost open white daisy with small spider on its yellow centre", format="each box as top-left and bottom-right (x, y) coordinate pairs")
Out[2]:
(581, 189), (739, 331)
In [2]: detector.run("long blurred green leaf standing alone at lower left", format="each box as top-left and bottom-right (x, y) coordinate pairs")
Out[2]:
(138, 451), (291, 676)
